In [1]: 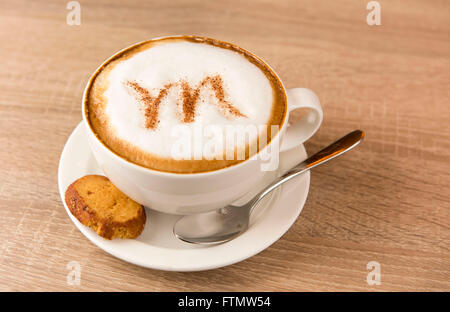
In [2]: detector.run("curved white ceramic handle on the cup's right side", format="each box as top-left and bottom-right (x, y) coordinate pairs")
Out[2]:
(280, 88), (323, 152)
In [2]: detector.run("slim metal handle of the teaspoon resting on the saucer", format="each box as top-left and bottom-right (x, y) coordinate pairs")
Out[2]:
(251, 130), (364, 207)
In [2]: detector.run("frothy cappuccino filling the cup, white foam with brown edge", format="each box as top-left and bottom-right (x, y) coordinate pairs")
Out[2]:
(84, 36), (286, 173)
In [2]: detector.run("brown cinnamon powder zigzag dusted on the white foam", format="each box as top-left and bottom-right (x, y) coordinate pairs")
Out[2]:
(125, 75), (247, 129)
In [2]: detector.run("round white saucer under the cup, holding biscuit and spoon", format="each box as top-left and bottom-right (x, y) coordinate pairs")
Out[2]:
(58, 123), (310, 271)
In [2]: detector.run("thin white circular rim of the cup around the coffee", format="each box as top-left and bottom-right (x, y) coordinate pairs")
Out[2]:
(81, 35), (289, 178)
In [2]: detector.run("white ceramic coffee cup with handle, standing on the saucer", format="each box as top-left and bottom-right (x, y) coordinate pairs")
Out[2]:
(82, 38), (323, 214)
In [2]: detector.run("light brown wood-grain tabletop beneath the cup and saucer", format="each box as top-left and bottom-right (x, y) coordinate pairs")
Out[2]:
(0, 0), (450, 291)
